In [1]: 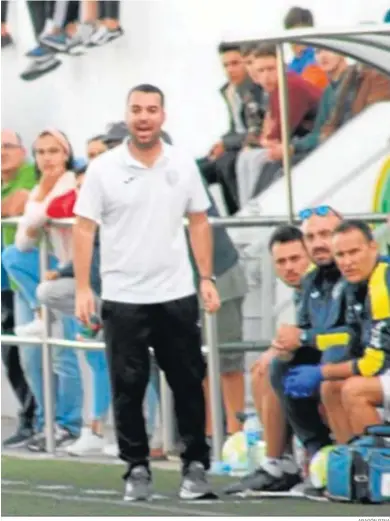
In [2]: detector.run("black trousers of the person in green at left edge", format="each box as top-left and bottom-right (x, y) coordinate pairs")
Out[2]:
(1, 290), (35, 430)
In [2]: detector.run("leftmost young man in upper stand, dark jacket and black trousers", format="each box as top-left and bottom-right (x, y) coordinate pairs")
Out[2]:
(198, 43), (262, 214)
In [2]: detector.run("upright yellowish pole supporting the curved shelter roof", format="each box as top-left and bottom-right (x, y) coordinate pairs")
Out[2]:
(276, 43), (294, 223)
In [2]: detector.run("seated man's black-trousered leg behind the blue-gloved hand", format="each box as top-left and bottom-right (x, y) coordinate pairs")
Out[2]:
(270, 348), (331, 456)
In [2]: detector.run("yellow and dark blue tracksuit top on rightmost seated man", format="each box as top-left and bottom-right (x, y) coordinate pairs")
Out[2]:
(347, 259), (390, 377)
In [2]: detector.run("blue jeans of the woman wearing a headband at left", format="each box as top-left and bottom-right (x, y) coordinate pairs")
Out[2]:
(2, 246), (83, 435)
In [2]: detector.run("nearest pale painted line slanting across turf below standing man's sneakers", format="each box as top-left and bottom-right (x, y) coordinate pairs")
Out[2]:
(3, 489), (230, 517)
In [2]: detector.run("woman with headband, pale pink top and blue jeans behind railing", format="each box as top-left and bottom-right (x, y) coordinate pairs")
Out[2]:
(2, 129), (82, 452)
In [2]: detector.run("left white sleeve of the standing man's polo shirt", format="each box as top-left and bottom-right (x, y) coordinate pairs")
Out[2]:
(73, 161), (103, 225)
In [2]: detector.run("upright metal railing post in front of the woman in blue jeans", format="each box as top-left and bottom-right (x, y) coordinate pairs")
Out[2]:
(39, 233), (55, 454)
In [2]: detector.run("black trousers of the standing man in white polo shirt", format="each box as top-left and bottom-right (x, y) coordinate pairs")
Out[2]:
(102, 295), (210, 470)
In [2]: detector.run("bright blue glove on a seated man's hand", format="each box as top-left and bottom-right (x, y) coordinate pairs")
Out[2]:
(284, 365), (324, 398)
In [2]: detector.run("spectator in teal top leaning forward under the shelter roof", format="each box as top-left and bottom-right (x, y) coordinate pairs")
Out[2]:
(290, 49), (348, 157)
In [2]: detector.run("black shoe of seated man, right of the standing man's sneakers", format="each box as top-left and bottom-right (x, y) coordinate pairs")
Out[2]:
(224, 467), (301, 495)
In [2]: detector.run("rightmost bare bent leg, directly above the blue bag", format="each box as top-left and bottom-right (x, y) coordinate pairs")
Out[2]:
(341, 373), (384, 436)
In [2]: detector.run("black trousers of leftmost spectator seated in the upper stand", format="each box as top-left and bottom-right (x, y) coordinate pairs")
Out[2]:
(197, 150), (239, 215)
